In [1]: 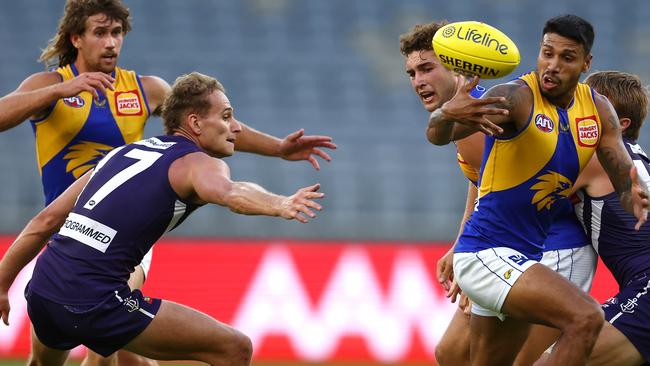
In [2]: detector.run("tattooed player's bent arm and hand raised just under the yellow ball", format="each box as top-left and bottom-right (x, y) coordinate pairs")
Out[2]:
(427, 78), (532, 145)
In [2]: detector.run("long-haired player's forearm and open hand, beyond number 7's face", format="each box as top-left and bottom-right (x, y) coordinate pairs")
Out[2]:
(235, 122), (336, 170)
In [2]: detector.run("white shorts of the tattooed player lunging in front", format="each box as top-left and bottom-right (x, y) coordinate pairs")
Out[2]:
(454, 247), (538, 320)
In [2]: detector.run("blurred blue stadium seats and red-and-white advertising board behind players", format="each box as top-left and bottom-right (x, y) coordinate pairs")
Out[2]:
(0, 0), (650, 362)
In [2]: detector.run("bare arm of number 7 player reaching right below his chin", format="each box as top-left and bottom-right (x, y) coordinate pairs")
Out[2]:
(169, 153), (324, 223)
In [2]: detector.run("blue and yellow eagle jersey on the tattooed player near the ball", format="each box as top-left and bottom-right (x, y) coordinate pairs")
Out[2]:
(456, 73), (601, 259)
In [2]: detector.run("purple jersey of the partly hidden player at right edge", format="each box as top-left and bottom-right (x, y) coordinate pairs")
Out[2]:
(576, 139), (650, 286)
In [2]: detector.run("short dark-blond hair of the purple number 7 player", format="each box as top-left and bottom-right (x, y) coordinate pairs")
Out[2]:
(162, 71), (226, 135)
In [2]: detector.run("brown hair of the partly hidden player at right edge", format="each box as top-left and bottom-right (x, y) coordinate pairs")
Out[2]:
(585, 71), (648, 141)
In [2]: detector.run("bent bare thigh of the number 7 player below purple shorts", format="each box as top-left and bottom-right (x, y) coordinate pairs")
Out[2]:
(124, 300), (252, 363)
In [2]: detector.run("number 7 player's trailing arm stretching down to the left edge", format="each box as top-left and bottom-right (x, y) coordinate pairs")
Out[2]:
(0, 174), (90, 325)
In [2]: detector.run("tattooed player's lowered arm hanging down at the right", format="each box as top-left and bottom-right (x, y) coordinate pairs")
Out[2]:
(595, 93), (648, 230)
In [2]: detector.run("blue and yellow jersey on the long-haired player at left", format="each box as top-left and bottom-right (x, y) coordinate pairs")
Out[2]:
(31, 64), (149, 204)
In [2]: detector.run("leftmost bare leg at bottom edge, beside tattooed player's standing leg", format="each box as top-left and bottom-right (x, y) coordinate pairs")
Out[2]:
(436, 308), (470, 366)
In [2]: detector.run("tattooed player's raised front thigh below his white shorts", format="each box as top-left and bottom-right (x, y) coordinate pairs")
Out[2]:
(502, 264), (602, 329)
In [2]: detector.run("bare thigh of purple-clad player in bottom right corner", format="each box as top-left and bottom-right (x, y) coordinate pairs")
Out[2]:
(587, 322), (645, 366)
